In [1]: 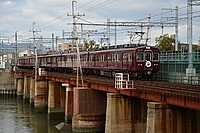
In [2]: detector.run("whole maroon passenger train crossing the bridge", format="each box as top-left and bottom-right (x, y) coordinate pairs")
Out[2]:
(17, 46), (160, 78)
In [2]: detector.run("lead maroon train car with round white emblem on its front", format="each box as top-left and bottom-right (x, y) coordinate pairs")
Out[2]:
(82, 46), (160, 78)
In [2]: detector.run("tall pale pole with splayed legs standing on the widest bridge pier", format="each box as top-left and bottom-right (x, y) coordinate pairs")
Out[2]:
(67, 0), (85, 87)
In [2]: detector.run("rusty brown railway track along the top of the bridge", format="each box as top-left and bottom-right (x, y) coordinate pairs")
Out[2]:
(18, 70), (200, 100)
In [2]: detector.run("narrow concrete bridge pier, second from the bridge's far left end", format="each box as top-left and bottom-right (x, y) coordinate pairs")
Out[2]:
(23, 76), (31, 102)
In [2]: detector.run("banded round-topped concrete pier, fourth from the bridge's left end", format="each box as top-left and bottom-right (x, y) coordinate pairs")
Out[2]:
(34, 77), (48, 112)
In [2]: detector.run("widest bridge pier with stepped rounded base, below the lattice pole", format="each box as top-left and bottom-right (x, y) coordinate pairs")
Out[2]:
(72, 87), (106, 132)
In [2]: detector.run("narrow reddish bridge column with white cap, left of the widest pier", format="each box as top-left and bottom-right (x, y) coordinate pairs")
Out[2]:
(62, 84), (74, 123)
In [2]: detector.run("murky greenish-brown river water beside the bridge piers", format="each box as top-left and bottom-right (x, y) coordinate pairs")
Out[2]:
(0, 95), (72, 133)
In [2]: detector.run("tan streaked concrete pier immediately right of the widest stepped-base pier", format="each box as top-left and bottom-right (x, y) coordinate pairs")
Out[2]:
(105, 93), (132, 133)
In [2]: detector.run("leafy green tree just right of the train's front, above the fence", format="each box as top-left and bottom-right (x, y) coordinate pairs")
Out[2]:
(155, 34), (175, 52)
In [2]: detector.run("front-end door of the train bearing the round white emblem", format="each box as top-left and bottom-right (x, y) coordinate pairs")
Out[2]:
(144, 50), (153, 70)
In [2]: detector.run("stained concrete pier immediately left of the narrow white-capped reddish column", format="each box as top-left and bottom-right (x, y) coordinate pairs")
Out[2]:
(48, 81), (65, 120)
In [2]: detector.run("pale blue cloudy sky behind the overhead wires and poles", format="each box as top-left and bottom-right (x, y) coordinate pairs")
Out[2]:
(0, 0), (200, 45)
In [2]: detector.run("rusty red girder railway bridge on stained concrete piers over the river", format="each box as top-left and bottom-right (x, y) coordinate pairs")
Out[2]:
(15, 69), (200, 133)
